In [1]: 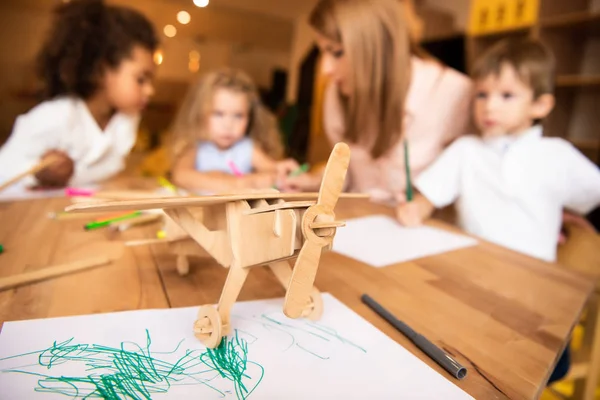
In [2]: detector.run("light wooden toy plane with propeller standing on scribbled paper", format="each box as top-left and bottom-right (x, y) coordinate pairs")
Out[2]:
(66, 143), (366, 348)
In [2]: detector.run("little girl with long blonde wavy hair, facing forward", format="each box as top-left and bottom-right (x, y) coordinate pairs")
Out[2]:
(172, 68), (283, 193)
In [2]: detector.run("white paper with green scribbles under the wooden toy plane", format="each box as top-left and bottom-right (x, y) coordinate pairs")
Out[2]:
(0, 294), (471, 400)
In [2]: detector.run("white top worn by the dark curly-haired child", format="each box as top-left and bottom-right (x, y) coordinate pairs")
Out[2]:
(0, 97), (139, 185)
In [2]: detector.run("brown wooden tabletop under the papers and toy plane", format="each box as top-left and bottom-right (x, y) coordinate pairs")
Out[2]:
(0, 195), (593, 399)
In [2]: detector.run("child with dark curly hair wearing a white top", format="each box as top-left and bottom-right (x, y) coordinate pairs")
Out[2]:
(0, 0), (158, 187)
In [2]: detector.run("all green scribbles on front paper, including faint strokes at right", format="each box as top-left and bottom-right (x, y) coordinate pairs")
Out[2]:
(0, 314), (367, 400)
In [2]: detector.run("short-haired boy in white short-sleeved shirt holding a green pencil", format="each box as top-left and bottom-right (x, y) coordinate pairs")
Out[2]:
(397, 36), (600, 261)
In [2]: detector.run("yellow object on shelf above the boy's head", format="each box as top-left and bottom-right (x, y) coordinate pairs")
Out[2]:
(469, 0), (539, 35)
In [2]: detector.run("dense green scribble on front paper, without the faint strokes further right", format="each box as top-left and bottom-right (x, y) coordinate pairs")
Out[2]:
(2, 330), (264, 400)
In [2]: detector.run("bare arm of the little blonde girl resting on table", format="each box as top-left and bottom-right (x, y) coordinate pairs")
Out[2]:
(173, 147), (275, 193)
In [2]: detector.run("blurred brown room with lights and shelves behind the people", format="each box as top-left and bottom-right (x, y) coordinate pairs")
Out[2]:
(0, 0), (600, 173)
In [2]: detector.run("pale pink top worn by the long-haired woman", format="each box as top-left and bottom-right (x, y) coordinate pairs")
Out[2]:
(323, 57), (472, 202)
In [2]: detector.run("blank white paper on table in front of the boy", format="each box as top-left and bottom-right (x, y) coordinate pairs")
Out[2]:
(332, 215), (477, 267)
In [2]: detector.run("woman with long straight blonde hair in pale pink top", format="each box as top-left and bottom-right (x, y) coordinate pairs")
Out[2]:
(279, 0), (471, 206)
